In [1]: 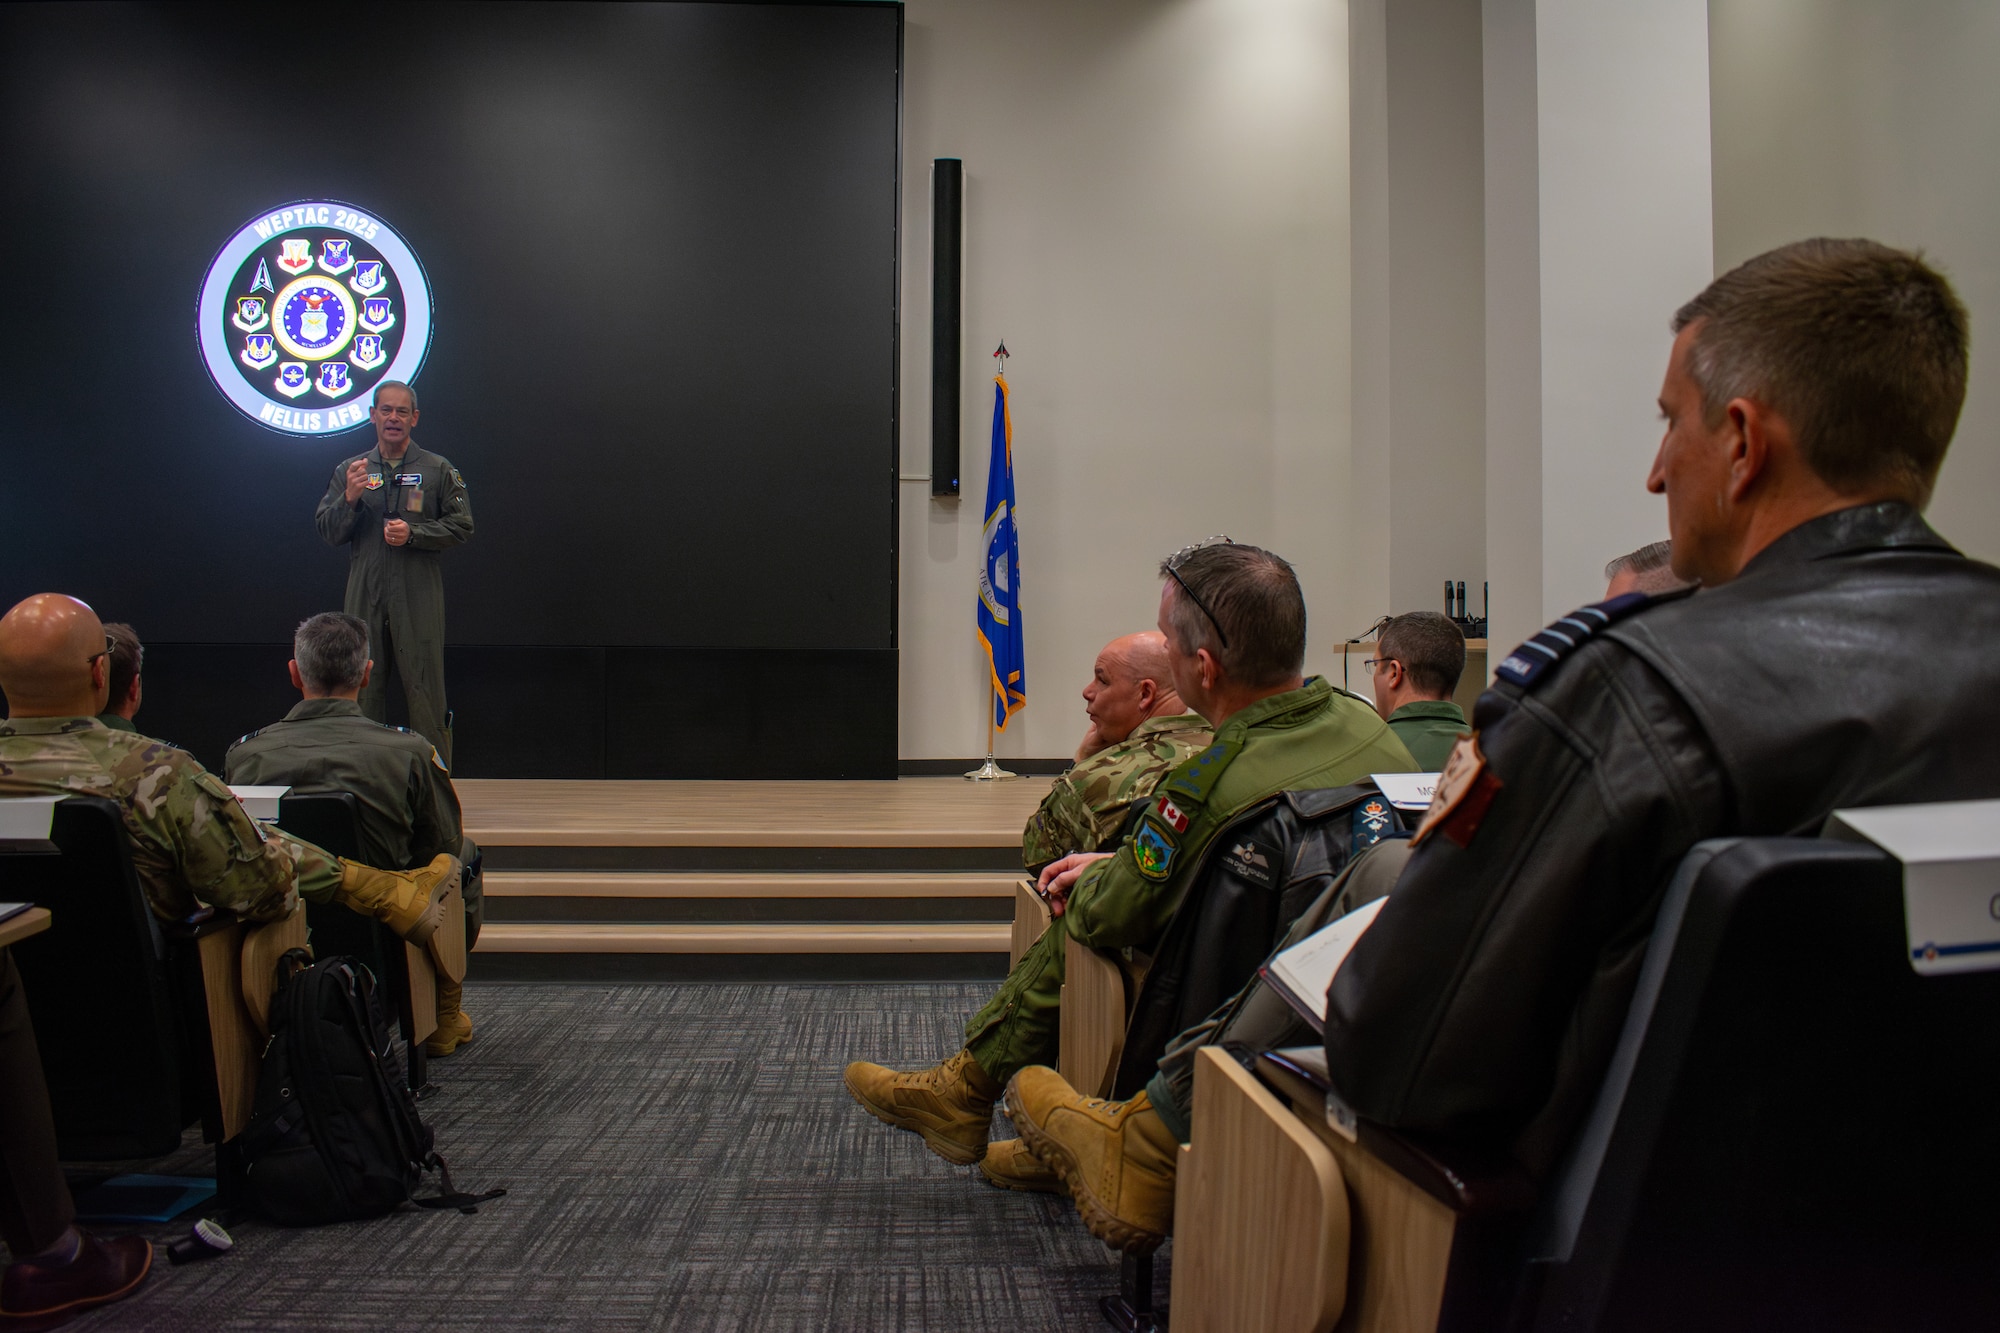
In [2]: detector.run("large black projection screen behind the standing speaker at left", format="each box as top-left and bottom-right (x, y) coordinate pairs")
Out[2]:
(0, 4), (900, 777)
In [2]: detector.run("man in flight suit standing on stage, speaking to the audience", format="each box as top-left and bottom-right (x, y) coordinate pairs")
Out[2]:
(314, 380), (472, 765)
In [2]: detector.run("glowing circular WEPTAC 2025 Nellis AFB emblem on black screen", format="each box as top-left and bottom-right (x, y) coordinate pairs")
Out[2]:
(194, 202), (430, 434)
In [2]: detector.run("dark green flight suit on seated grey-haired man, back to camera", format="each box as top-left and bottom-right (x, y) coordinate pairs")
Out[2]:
(222, 699), (486, 945)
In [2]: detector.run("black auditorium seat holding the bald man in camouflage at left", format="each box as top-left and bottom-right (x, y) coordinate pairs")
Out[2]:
(0, 797), (306, 1193)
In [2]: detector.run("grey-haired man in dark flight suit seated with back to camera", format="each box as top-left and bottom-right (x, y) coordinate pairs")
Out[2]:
(224, 610), (482, 1055)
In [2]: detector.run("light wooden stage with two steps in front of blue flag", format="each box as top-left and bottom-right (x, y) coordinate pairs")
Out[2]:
(458, 777), (1050, 981)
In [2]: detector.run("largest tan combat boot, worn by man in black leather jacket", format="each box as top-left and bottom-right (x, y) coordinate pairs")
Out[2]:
(1006, 1065), (1180, 1255)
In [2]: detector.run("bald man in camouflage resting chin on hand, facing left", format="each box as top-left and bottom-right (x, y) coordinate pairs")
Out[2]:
(1020, 630), (1208, 875)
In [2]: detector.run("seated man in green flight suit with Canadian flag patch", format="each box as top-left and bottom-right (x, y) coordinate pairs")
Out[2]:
(846, 538), (1416, 1189)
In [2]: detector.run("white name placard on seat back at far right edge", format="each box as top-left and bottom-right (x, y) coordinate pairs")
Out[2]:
(1826, 801), (2000, 975)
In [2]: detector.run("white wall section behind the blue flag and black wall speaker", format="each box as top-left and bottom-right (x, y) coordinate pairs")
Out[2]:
(900, 0), (1360, 759)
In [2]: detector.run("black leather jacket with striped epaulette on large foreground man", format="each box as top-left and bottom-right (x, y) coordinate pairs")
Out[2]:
(1326, 504), (2000, 1173)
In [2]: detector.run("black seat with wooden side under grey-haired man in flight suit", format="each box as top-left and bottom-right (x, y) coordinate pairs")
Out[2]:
(278, 791), (442, 1093)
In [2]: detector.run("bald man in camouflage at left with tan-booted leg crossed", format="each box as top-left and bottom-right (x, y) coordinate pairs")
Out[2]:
(0, 592), (460, 945)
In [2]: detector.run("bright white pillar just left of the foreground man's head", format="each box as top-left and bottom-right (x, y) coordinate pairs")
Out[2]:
(1484, 0), (1714, 660)
